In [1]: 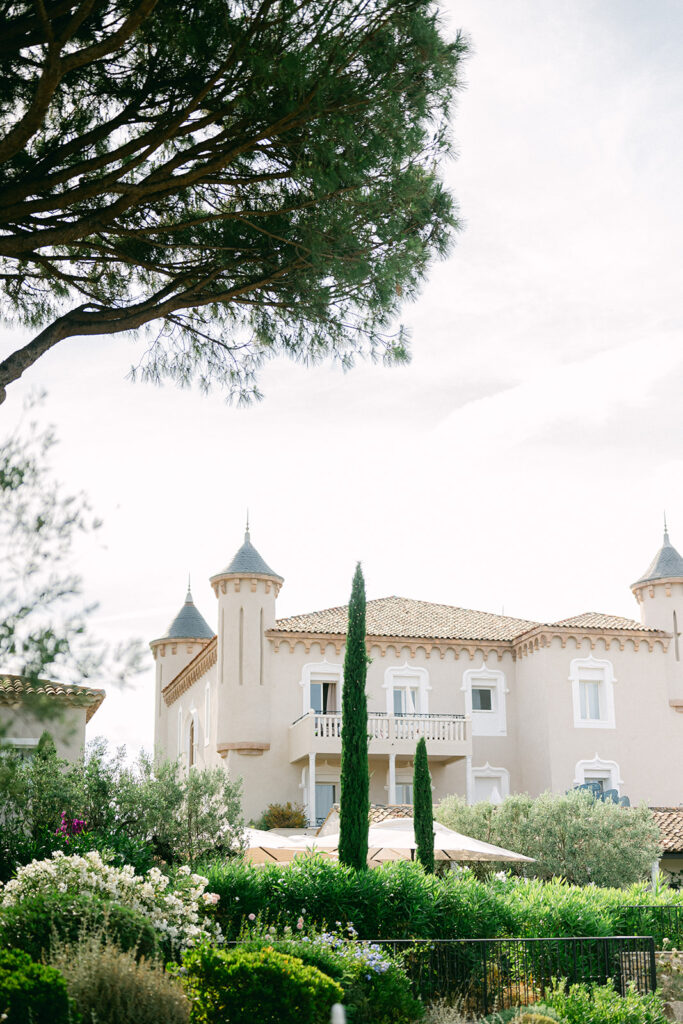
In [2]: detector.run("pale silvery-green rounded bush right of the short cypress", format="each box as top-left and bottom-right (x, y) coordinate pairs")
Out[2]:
(435, 790), (660, 886)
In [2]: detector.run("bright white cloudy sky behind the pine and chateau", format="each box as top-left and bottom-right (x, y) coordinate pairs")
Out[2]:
(0, 0), (683, 756)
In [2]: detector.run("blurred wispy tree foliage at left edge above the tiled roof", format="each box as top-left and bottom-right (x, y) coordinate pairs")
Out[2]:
(0, 407), (140, 704)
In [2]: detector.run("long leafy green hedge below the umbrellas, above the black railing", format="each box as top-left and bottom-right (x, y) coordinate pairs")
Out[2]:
(202, 857), (683, 942)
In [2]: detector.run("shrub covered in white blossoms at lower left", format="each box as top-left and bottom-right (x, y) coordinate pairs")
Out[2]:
(0, 851), (220, 949)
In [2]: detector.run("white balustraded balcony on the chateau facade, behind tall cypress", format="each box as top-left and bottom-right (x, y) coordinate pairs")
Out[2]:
(289, 711), (472, 763)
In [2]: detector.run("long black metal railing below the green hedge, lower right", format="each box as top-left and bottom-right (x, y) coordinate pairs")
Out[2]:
(377, 935), (656, 1016)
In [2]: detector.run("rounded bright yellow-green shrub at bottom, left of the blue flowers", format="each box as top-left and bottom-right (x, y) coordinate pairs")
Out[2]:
(176, 944), (343, 1024)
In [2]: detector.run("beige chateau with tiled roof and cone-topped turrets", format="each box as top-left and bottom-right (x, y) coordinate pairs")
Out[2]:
(151, 529), (683, 822)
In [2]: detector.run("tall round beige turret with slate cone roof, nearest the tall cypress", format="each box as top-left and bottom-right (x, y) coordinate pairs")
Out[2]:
(211, 522), (284, 757)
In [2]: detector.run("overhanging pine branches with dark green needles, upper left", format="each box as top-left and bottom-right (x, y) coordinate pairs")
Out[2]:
(0, 0), (467, 397)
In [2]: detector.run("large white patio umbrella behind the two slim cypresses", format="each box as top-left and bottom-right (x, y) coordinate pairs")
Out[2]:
(298, 818), (533, 864)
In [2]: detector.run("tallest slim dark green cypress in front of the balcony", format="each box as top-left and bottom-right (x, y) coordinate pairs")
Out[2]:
(339, 562), (370, 870)
